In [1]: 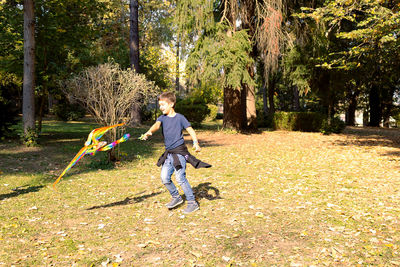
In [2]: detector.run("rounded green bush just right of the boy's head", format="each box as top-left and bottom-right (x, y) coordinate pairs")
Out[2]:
(175, 97), (210, 127)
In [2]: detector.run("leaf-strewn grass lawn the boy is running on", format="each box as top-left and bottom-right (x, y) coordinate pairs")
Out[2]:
(0, 120), (400, 266)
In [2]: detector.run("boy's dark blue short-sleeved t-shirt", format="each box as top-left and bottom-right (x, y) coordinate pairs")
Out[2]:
(157, 113), (190, 150)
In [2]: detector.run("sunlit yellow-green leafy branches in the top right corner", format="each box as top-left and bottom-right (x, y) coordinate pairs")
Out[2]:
(297, 0), (400, 71)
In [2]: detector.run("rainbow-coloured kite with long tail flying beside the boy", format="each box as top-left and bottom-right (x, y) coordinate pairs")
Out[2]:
(53, 123), (130, 186)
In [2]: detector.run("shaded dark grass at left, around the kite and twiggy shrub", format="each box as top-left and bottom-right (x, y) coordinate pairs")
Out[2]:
(0, 119), (162, 178)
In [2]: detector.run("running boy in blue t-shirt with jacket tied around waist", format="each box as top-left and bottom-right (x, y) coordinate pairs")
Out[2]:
(141, 92), (211, 214)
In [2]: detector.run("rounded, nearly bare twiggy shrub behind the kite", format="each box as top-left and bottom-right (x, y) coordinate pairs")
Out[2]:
(62, 63), (157, 160)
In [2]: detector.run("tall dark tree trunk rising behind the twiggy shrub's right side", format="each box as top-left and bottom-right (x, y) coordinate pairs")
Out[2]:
(129, 0), (139, 73)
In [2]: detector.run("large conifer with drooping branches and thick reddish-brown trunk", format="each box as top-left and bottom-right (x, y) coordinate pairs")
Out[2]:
(176, 0), (282, 131)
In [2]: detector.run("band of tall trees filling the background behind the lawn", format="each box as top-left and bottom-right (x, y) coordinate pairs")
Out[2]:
(0, 0), (400, 142)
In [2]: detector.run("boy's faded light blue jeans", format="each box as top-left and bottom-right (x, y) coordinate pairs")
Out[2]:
(161, 154), (194, 201)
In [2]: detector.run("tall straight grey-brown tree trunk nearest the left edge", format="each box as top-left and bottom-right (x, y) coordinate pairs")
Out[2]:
(22, 0), (35, 135)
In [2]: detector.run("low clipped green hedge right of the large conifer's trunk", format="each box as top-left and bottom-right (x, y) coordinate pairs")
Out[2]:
(270, 111), (324, 132)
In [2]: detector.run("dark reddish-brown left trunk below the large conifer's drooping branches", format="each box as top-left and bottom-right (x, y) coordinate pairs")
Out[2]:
(223, 87), (242, 131)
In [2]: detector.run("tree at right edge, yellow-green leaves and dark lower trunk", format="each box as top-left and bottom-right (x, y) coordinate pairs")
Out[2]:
(301, 0), (400, 126)
